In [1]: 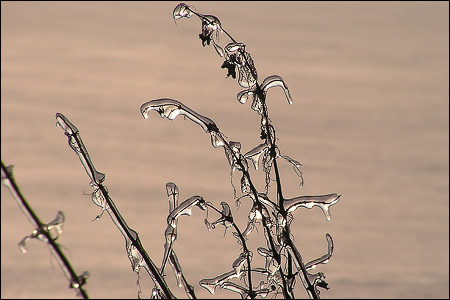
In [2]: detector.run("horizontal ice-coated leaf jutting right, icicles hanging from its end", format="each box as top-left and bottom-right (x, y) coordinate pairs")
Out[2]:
(283, 193), (341, 221)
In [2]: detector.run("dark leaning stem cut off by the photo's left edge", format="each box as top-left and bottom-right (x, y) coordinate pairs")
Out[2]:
(1, 161), (89, 299)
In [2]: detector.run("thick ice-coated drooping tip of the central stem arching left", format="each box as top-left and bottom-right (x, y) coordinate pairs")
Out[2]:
(141, 98), (219, 133)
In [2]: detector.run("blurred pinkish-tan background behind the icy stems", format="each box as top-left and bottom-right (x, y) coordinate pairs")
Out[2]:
(1, 2), (449, 298)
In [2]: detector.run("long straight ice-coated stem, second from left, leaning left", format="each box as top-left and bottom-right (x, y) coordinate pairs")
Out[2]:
(56, 113), (174, 299)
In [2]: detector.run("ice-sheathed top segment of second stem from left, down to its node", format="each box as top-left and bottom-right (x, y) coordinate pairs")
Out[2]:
(56, 113), (105, 186)
